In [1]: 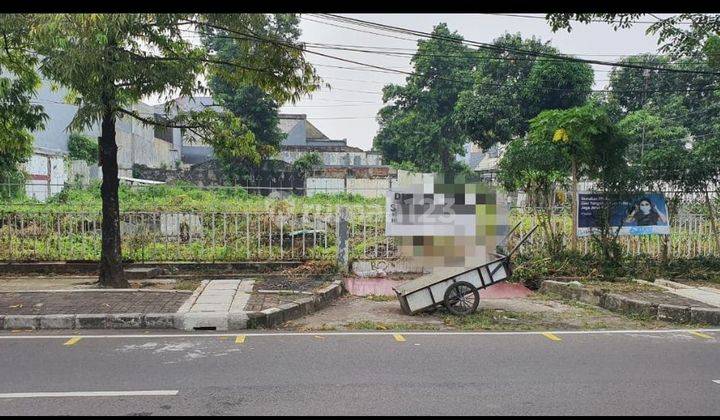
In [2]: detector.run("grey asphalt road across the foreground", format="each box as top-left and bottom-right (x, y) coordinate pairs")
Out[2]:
(0, 330), (720, 416)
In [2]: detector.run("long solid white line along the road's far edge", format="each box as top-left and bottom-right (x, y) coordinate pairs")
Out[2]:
(0, 328), (720, 340)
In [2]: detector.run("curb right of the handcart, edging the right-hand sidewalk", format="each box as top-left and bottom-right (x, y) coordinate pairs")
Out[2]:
(539, 280), (720, 325)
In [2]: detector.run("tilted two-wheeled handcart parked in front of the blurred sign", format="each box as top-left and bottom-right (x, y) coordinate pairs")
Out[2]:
(393, 223), (537, 315)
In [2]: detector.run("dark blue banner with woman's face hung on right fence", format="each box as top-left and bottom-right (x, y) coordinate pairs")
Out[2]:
(577, 192), (670, 236)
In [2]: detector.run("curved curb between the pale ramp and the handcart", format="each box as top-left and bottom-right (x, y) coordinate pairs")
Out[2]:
(247, 280), (343, 328)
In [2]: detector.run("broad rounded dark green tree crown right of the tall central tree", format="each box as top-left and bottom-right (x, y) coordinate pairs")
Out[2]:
(456, 34), (593, 148)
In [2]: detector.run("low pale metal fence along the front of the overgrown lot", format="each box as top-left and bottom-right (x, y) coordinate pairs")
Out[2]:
(0, 207), (720, 262)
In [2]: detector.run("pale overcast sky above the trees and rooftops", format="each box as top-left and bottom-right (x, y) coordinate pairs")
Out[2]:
(281, 14), (667, 150)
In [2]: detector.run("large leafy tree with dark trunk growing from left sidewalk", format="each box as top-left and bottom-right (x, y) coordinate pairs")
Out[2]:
(9, 13), (318, 287)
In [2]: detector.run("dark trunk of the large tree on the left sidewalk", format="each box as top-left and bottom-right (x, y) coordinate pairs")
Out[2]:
(100, 107), (130, 288)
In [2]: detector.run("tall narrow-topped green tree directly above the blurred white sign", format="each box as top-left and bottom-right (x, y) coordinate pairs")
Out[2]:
(373, 23), (475, 173)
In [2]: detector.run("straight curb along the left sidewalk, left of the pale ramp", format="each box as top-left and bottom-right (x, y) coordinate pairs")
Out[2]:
(0, 312), (175, 330)
